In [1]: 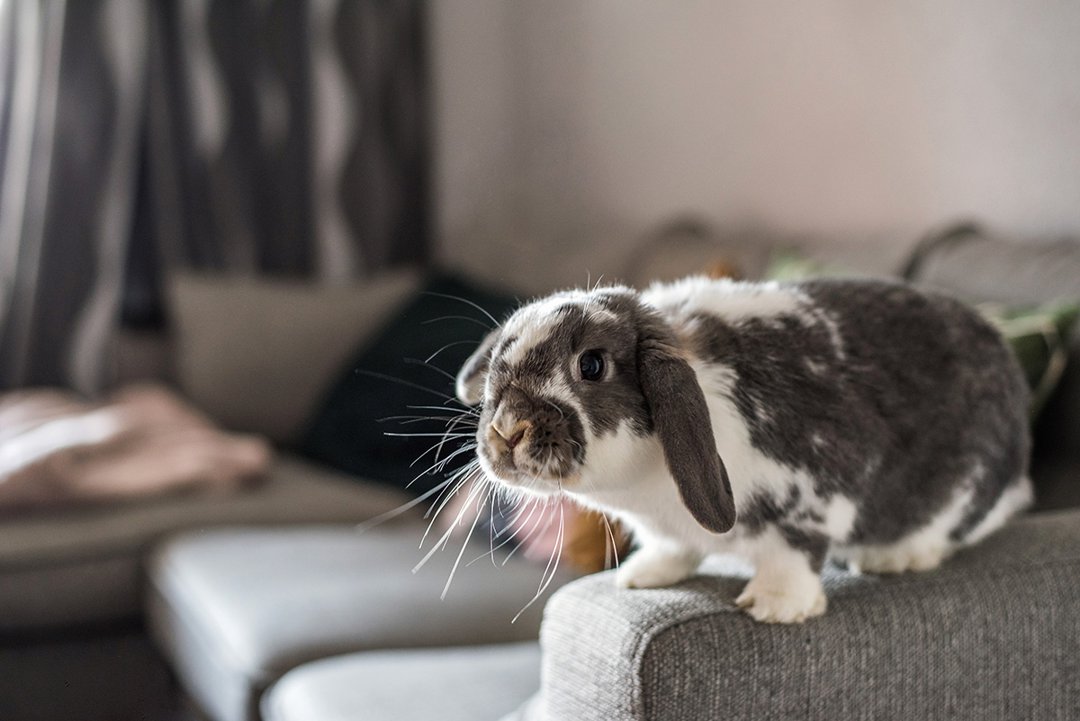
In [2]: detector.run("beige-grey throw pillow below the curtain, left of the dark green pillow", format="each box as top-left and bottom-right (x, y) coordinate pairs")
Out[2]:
(170, 271), (420, 443)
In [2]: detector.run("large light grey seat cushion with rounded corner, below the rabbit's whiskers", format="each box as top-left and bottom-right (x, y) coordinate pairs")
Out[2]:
(150, 523), (574, 721)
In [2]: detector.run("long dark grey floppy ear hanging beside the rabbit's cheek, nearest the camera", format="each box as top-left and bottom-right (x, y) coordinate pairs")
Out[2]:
(637, 339), (735, 533)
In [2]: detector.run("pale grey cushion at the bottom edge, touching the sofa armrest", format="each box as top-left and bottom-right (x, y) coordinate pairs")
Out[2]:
(262, 642), (540, 721)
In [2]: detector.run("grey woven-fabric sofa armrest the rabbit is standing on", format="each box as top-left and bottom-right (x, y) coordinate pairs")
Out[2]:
(542, 511), (1080, 721)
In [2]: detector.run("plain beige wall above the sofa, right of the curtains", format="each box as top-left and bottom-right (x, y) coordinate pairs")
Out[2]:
(432, 0), (1080, 285)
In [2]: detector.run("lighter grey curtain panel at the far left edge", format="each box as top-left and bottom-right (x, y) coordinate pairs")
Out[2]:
(0, 0), (147, 391)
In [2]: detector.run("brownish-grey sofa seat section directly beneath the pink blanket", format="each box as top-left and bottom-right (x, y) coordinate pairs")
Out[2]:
(0, 457), (407, 634)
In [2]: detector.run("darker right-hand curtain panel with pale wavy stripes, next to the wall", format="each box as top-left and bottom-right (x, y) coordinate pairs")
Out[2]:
(144, 0), (427, 278)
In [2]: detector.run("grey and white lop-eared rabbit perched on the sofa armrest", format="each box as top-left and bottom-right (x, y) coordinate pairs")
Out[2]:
(456, 277), (1032, 623)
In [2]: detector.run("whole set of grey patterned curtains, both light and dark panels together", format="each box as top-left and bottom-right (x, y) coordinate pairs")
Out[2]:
(0, 0), (429, 393)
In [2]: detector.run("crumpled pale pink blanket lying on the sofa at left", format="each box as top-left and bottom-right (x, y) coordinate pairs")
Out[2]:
(0, 385), (270, 512)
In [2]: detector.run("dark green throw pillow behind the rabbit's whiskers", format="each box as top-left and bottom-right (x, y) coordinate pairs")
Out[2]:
(298, 275), (517, 493)
